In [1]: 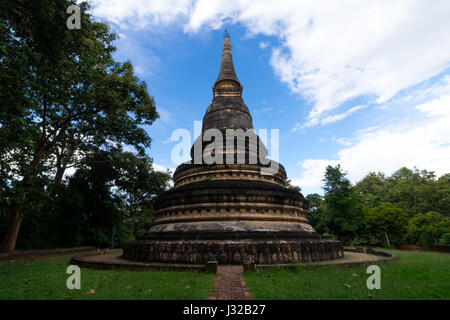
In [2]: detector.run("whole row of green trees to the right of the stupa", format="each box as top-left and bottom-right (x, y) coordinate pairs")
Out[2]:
(306, 165), (450, 246)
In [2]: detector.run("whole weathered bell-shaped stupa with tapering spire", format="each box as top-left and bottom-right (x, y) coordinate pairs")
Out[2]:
(122, 34), (344, 264)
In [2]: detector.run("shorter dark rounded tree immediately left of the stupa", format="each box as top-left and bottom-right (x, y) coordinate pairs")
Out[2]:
(60, 149), (171, 247)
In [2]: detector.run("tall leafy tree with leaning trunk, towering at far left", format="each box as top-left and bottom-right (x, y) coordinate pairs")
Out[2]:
(0, 0), (158, 251)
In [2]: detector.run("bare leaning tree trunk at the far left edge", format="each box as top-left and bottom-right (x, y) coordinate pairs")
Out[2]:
(2, 146), (45, 252)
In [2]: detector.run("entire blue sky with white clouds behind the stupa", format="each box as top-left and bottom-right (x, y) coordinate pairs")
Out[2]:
(89, 0), (450, 194)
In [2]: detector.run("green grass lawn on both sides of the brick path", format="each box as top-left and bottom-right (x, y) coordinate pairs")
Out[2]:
(0, 249), (450, 300)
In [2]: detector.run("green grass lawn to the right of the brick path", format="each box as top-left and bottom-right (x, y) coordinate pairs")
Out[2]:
(245, 249), (450, 300)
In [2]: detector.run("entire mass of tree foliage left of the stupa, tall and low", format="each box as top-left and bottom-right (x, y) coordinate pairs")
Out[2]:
(0, 0), (170, 248)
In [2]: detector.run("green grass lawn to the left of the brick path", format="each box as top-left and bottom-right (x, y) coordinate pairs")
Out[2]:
(0, 256), (215, 300)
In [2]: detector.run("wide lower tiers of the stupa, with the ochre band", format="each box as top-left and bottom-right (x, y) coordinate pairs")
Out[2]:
(122, 180), (344, 264)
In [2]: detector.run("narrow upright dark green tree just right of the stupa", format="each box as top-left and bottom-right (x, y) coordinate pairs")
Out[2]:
(323, 164), (362, 244)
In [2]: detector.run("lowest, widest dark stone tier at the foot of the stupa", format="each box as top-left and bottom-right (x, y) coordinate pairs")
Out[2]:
(122, 239), (344, 264)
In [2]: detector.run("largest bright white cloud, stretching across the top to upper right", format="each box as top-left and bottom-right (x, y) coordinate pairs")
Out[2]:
(94, 0), (450, 125)
